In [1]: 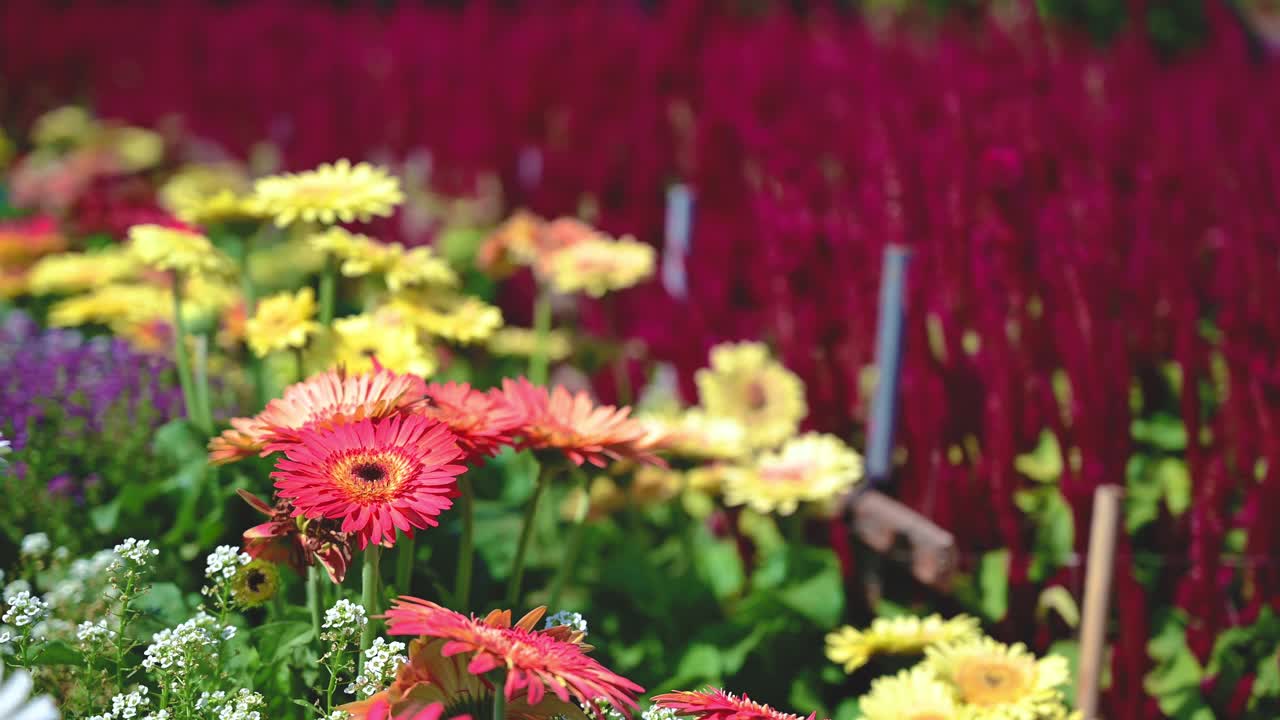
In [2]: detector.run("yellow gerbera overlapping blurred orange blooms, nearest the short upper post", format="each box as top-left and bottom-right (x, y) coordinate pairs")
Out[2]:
(539, 230), (654, 297)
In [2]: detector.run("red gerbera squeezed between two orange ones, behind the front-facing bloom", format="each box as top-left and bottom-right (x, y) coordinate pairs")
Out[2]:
(417, 383), (522, 460)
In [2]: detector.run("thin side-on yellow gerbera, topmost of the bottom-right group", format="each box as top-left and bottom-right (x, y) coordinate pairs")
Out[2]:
(827, 614), (982, 673)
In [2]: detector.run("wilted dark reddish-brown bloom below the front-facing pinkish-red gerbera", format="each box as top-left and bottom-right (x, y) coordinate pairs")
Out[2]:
(236, 489), (351, 584)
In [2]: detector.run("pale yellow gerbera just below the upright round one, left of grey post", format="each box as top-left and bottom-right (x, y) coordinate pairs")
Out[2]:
(723, 433), (863, 515)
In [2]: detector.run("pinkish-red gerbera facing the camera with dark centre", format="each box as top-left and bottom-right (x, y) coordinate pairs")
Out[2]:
(271, 415), (466, 548)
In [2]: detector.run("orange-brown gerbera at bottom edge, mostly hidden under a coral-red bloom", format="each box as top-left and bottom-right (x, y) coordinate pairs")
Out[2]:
(339, 638), (586, 720)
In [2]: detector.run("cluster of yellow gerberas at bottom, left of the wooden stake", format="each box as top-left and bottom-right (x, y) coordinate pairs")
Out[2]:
(827, 615), (1078, 720)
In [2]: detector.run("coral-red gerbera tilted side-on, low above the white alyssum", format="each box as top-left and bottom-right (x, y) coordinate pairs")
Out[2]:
(387, 597), (644, 712)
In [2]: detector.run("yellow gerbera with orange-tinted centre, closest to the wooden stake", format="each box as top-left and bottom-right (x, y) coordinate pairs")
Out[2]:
(924, 637), (1070, 720)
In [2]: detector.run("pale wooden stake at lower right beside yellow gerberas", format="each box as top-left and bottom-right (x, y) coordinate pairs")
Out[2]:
(1075, 486), (1124, 720)
